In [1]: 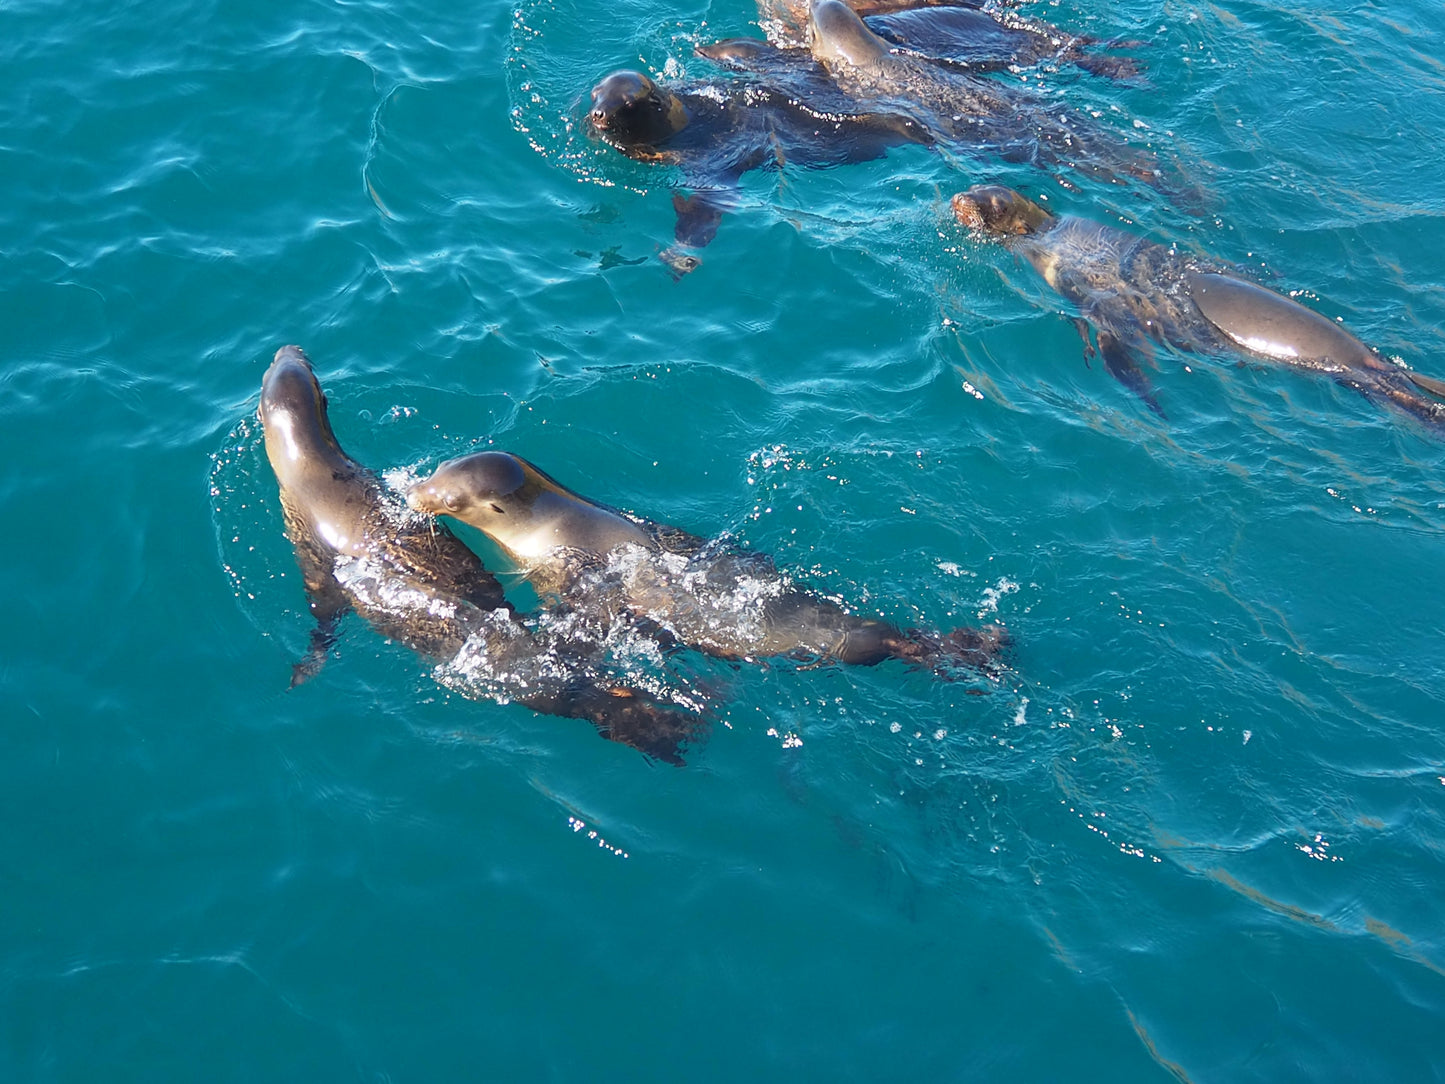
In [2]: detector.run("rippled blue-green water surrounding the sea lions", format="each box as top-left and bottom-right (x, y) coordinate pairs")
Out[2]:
(0, 0), (1445, 1081)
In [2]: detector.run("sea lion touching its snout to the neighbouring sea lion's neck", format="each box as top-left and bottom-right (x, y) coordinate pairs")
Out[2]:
(406, 451), (1007, 675)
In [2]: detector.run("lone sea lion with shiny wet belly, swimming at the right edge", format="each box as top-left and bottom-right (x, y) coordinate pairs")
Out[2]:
(952, 185), (1445, 425)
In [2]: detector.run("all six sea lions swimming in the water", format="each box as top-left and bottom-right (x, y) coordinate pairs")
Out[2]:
(248, 0), (1445, 763)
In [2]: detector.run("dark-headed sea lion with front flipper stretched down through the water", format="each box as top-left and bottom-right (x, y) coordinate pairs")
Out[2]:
(587, 71), (931, 275)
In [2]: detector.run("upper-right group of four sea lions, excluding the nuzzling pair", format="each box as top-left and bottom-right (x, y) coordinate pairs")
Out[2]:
(587, 0), (1445, 425)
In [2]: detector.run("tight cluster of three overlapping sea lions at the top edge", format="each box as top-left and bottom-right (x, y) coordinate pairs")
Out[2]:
(585, 0), (1201, 265)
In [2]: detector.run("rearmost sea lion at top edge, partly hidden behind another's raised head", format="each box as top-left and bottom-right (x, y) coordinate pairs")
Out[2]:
(757, 0), (1140, 79)
